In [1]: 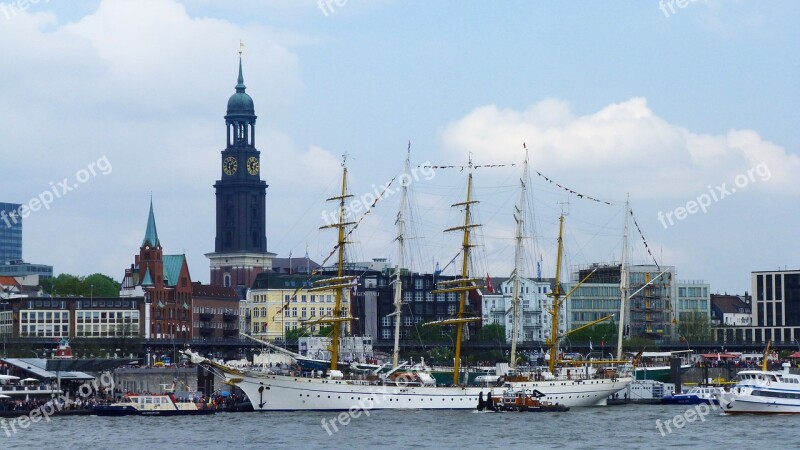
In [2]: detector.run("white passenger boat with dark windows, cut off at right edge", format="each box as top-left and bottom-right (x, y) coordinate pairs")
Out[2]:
(716, 360), (800, 414)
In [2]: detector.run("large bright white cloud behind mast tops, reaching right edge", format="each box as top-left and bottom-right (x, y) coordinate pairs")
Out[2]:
(442, 97), (800, 199)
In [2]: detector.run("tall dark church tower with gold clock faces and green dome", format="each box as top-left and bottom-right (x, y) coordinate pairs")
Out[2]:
(206, 52), (275, 298)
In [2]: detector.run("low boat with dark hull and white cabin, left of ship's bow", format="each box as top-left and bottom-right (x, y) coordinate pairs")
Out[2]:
(94, 394), (214, 416)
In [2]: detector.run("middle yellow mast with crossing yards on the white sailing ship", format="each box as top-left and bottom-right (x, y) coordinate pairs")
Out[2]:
(426, 160), (483, 385)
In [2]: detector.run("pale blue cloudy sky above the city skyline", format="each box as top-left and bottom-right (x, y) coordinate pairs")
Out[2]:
(0, 0), (800, 294)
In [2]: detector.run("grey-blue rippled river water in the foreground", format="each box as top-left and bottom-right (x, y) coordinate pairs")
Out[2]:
(0, 405), (800, 450)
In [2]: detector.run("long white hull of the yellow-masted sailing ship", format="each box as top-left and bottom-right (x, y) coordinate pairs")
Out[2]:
(226, 374), (632, 411)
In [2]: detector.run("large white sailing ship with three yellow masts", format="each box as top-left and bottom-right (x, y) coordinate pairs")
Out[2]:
(185, 150), (632, 411)
